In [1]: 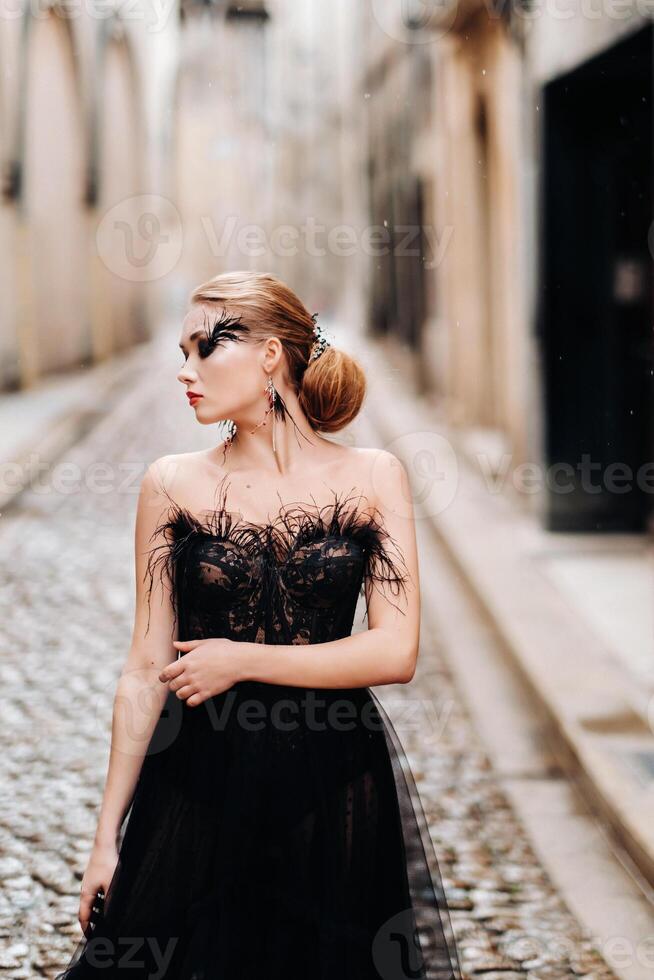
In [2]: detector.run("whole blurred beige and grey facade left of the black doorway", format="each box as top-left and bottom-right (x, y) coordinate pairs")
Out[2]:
(353, 0), (529, 462)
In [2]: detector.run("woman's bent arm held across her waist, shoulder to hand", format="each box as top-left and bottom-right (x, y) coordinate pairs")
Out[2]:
(159, 450), (420, 706)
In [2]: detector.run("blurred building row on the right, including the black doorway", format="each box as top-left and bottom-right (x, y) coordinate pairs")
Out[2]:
(354, 0), (654, 531)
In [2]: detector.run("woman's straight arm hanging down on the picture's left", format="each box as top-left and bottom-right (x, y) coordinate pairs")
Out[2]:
(79, 460), (177, 933)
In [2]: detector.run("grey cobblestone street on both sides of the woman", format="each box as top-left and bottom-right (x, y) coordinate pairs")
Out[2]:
(0, 340), (624, 980)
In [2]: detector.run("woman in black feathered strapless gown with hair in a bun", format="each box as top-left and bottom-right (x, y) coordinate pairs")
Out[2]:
(57, 272), (460, 980)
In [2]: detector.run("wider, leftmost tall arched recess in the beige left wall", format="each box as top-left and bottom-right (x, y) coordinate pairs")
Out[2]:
(23, 11), (91, 374)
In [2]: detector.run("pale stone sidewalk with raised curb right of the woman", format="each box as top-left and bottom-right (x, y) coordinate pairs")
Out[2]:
(363, 334), (654, 889)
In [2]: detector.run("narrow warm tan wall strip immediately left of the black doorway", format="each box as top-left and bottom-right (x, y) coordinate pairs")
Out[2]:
(437, 13), (527, 458)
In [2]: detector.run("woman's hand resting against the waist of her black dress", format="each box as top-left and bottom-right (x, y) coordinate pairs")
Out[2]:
(159, 637), (247, 707)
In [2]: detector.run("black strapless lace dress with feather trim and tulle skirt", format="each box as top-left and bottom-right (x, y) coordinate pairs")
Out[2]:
(56, 478), (461, 980)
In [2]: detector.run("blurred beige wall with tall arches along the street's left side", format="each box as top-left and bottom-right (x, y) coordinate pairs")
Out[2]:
(0, 0), (179, 387)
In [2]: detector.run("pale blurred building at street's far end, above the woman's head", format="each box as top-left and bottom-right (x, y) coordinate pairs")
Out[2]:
(174, 0), (358, 311)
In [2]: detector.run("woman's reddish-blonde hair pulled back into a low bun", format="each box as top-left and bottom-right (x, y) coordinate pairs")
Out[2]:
(189, 270), (366, 432)
